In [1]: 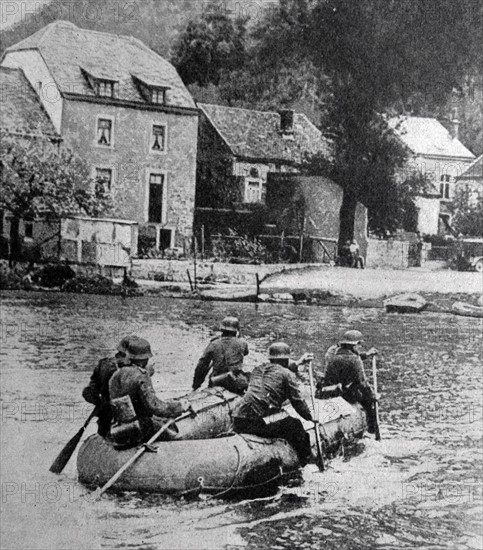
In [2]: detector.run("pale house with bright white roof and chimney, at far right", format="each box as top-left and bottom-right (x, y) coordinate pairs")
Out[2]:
(389, 116), (475, 235)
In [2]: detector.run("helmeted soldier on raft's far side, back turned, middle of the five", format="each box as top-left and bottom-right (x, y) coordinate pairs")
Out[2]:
(193, 317), (248, 395)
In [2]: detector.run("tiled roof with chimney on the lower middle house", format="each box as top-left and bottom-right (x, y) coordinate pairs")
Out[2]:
(198, 103), (329, 164)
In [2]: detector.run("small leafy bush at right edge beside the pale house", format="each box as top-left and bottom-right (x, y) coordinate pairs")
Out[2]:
(451, 187), (483, 237)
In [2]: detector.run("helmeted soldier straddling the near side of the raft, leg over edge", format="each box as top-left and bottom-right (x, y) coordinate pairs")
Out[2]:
(233, 342), (313, 464)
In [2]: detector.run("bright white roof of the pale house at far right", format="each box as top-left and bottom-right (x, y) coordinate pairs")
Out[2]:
(389, 117), (475, 159)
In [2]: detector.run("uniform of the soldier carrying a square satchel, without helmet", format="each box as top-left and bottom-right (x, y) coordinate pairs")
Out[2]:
(109, 364), (186, 440)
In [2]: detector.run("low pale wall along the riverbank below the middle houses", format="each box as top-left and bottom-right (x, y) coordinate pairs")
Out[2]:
(132, 260), (318, 285)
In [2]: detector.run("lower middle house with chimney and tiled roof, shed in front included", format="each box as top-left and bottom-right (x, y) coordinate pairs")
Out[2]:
(195, 104), (367, 261)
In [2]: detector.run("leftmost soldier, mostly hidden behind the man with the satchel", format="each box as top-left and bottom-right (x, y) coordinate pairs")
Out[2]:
(82, 336), (132, 437)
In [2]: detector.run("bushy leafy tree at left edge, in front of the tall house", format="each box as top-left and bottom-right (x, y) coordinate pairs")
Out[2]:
(0, 132), (111, 262)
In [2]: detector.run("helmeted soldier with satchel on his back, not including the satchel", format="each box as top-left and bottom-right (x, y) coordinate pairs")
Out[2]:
(109, 337), (189, 441)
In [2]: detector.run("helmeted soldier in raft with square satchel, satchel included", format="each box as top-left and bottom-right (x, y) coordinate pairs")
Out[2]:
(109, 337), (190, 446)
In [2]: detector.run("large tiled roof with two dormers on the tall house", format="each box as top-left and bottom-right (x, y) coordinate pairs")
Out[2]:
(5, 21), (196, 108)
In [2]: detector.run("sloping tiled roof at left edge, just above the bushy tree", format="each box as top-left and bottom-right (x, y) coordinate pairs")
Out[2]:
(0, 67), (59, 138)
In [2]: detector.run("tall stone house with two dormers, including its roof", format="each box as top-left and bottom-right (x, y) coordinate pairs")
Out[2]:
(1, 21), (198, 253)
